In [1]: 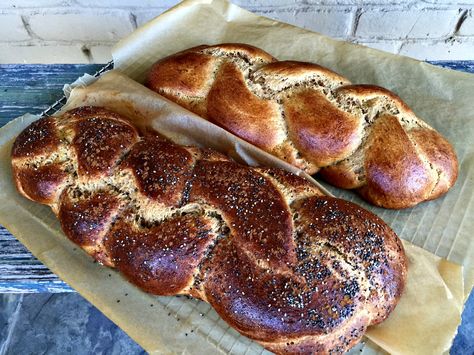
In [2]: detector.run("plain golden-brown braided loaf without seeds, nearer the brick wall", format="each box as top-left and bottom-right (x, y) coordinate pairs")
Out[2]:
(146, 44), (458, 208)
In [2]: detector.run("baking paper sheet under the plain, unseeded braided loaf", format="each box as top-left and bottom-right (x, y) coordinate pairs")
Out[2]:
(112, 0), (474, 297)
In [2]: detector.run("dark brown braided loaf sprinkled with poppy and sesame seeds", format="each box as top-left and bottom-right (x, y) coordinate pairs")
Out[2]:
(12, 107), (406, 353)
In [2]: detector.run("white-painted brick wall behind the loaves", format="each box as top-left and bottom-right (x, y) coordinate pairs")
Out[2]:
(0, 0), (474, 63)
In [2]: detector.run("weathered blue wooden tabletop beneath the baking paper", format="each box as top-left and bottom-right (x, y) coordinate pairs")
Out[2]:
(0, 60), (474, 293)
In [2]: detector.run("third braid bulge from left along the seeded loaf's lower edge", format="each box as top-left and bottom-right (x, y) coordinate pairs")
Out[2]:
(105, 215), (216, 295)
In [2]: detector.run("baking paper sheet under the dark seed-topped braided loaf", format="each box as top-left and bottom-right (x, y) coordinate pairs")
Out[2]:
(0, 71), (463, 354)
